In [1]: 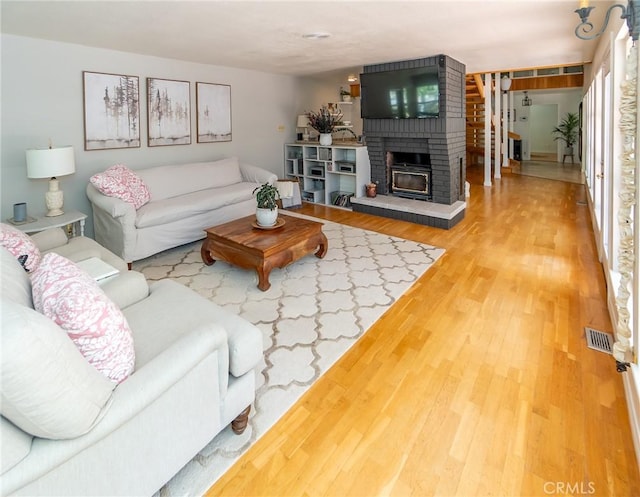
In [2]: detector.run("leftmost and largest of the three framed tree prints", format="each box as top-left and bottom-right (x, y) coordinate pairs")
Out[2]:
(82, 71), (140, 150)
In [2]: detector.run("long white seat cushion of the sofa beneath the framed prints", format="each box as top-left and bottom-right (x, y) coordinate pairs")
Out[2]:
(136, 182), (257, 228)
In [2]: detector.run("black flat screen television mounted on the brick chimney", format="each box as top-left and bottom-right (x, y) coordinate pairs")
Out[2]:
(360, 66), (440, 119)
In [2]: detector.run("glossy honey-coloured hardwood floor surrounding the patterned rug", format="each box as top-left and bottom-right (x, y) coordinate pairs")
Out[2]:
(207, 168), (640, 496)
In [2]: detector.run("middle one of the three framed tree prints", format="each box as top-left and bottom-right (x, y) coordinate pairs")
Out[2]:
(147, 78), (191, 147)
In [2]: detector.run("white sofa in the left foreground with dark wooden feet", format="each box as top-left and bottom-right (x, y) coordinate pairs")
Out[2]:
(0, 230), (262, 496)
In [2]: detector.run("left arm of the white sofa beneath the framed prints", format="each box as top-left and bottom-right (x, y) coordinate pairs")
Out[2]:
(87, 183), (136, 262)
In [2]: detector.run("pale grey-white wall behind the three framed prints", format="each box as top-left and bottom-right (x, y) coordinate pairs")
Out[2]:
(0, 34), (299, 235)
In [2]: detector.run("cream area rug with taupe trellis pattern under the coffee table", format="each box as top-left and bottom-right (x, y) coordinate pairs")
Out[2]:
(133, 216), (444, 497)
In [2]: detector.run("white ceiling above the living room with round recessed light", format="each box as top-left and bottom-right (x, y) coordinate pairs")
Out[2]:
(1, 0), (620, 75)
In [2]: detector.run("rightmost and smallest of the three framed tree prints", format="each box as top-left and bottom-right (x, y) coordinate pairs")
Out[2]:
(196, 83), (231, 143)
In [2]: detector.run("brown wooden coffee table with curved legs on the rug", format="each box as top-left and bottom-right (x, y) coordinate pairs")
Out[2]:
(200, 213), (328, 292)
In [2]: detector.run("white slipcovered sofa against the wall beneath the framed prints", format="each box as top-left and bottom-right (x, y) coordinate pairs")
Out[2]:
(87, 157), (277, 263)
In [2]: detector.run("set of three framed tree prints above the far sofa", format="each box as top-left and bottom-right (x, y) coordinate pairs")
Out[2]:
(83, 71), (231, 150)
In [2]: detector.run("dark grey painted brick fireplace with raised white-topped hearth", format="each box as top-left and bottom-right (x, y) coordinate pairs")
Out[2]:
(353, 55), (466, 228)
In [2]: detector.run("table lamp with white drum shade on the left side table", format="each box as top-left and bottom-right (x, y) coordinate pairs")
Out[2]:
(27, 142), (76, 217)
